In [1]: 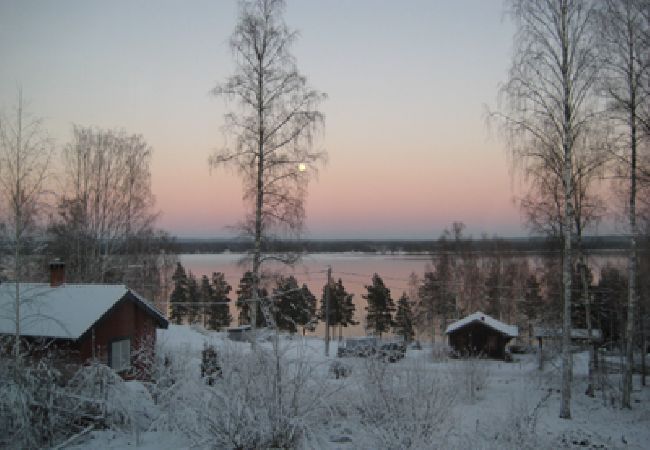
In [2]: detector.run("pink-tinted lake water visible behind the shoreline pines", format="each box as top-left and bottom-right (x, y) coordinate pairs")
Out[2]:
(180, 253), (624, 336)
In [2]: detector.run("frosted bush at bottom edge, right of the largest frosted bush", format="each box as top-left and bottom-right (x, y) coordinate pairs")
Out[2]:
(355, 358), (456, 449)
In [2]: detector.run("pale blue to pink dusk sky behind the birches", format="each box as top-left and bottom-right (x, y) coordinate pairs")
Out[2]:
(0, 0), (525, 239)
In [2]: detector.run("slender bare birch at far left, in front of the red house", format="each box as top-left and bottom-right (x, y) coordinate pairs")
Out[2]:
(0, 89), (54, 376)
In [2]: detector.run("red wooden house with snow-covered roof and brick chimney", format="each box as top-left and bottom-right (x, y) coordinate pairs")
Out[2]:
(0, 263), (168, 378)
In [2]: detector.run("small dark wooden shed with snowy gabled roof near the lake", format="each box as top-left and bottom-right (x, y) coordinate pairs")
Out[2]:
(445, 311), (519, 359)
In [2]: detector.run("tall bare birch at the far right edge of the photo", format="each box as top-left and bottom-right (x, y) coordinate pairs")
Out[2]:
(597, 0), (650, 408)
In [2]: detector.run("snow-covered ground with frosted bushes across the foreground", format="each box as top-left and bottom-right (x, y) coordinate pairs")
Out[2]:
(70, 325), (650, 449)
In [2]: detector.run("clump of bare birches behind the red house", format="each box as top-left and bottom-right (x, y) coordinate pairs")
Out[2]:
(50, 126), (162, 282)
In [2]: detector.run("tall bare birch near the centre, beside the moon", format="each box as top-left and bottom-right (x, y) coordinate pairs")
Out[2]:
(209, 0), (326, 338)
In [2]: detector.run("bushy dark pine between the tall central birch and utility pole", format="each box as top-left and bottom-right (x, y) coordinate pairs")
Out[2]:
(273, 276), (316, 334)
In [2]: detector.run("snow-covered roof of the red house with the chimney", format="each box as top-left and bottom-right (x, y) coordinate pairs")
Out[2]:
(0, 283), (168, 339)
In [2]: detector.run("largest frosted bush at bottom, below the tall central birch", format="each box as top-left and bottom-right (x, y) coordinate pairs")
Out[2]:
(153, 343), (336, 448)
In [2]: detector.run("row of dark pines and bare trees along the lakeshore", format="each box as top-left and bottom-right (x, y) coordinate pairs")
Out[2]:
(163, 222), (636, 356)
